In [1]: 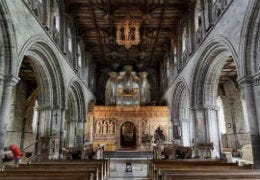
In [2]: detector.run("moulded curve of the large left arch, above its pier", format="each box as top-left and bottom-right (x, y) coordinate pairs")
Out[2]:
(16, 37), (65, 108)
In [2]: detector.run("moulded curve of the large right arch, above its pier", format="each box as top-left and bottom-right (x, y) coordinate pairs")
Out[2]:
(191, 37), (241, 108)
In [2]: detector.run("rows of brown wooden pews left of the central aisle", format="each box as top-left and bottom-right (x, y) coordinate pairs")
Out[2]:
(0, 160), (108, 180)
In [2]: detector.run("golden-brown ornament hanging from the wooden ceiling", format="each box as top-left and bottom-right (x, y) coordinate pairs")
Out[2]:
(116, 15), (140, 49)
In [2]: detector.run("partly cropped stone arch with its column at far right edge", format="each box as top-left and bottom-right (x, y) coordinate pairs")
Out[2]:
(239, 1), (260, 168)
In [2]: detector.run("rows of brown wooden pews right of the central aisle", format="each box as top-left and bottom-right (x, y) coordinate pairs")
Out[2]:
(149, 160), (260, 180)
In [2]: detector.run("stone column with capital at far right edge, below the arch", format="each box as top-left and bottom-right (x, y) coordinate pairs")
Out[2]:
(239, 79), (260, 168)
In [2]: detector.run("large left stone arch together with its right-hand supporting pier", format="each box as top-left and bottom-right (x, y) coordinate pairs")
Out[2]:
(7, 41), (65, 158)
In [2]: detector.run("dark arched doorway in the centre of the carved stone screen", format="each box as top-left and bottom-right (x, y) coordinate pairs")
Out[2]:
(120, 121), (136, 148)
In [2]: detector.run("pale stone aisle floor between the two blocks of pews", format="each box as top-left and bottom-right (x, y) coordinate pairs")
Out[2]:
(109, 158), (149, 180)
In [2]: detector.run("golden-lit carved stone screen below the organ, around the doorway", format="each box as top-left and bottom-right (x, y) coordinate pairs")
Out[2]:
(86, 106), (171, 151)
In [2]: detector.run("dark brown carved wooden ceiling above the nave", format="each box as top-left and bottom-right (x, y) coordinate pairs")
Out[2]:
(67, 0), (188, 65)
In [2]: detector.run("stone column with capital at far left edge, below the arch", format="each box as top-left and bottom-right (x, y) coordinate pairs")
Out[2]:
(0, 76), (19, 166)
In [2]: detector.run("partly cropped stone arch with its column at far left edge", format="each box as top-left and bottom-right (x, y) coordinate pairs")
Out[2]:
(0, 1), (19, 165)
